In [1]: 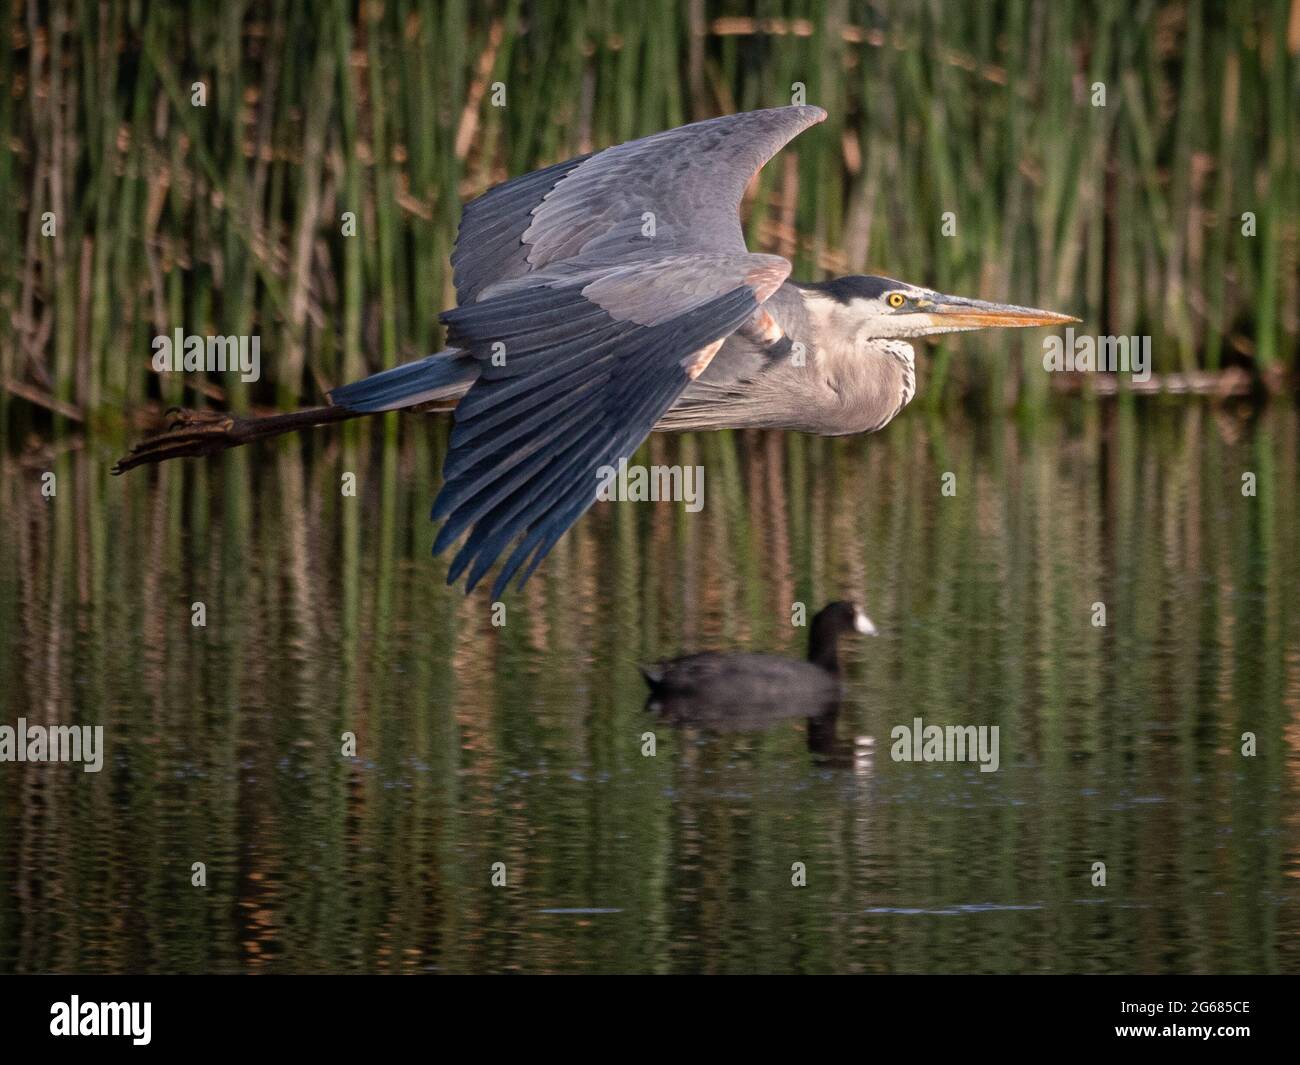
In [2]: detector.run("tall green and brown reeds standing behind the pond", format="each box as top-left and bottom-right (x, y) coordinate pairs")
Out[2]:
(0, 0), (1300, 433)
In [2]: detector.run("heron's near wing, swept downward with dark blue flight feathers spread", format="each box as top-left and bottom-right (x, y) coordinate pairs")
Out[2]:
(433, 255), (790, 596)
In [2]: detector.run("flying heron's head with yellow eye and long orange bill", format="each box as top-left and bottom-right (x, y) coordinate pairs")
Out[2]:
(810, 274), (1079, 339)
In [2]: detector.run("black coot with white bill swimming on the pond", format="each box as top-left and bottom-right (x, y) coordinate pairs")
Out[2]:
(641, 601), (876, 728)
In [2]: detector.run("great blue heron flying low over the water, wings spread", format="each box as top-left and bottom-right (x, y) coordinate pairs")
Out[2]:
(114, 107), (1078, 597)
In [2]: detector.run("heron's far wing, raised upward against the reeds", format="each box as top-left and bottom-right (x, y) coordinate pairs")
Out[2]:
(451, 107), (826, 306)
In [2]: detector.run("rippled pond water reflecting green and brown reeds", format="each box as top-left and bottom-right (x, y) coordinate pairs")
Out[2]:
(0, 403), (1300, 973)
